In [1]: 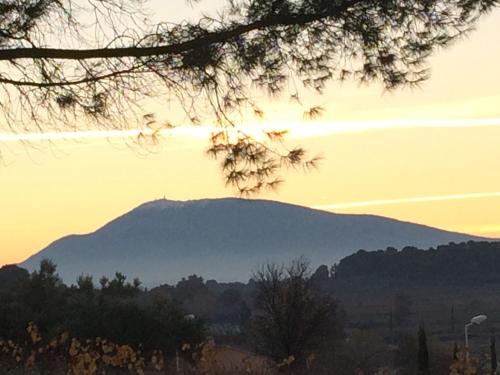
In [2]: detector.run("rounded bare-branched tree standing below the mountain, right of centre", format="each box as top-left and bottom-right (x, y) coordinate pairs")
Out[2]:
(253, 259), (340, 365)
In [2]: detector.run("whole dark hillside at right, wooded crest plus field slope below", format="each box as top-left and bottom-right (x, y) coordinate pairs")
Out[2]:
(310, 241), (500, 347)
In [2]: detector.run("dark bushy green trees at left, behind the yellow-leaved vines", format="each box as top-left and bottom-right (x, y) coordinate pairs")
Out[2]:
(0, 260), (205, 354)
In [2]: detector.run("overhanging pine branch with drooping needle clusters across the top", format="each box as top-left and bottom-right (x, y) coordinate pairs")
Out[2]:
(0, 0), (498, 193)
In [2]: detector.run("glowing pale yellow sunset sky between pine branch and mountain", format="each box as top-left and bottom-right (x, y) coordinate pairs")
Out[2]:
(0, 0), (500, 265)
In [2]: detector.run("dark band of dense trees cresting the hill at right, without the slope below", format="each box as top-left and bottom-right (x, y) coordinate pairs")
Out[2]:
(332, 241), (500, 288)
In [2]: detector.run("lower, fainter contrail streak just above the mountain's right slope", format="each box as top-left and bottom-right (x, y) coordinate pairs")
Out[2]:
(313, 191), (500, 210)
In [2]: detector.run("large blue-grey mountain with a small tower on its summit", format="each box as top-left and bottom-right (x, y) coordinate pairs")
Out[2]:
(20, 198), (486, 285)
